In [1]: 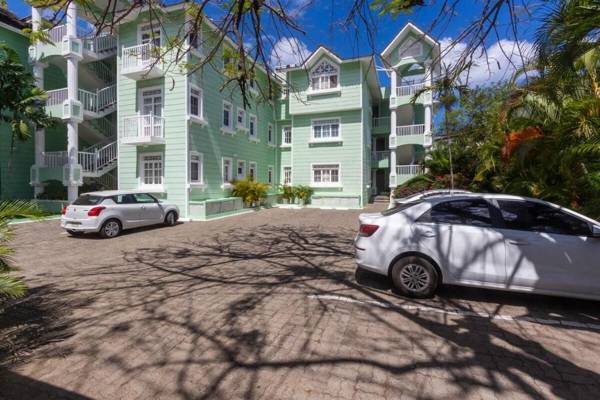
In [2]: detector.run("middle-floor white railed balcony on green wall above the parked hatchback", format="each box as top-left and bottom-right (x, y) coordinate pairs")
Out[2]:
(120, 114), (165, 145)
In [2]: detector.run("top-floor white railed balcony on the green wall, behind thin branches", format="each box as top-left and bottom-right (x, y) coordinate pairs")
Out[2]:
(121, 43), (164, 80)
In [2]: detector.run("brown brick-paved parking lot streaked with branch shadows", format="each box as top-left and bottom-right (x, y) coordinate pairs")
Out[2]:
(0, 209), (600, 399)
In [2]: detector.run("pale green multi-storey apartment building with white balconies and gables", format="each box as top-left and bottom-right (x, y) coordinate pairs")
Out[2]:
(0, 3), (439, 219)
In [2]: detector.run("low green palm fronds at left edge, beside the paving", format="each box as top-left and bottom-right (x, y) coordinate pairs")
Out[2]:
(0, 200), (40, 298)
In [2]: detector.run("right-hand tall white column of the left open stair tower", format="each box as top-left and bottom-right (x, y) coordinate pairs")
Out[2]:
(67, 2), (79, 202)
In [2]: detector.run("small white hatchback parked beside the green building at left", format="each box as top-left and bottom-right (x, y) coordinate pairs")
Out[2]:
(61, 190), (179, 238)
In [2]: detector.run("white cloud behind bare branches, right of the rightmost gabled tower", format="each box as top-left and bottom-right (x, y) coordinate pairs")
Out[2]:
(440, 38), (533, 85)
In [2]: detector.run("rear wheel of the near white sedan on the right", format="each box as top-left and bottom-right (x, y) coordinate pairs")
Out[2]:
(391, 256), (440, 299)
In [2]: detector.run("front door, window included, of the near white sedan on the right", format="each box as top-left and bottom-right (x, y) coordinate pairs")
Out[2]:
(498, 200), (600, 296)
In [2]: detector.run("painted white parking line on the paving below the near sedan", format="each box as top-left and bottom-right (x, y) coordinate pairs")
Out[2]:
(308, 294), (600, 331)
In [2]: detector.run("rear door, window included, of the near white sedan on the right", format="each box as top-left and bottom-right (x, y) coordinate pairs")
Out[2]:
(413, 199), (506, 286)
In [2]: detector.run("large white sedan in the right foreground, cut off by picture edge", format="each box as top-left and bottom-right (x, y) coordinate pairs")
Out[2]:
(355, 194), (600, 300)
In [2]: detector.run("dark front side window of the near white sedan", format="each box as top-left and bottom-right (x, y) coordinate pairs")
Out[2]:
(498, 200), (590, 236)
